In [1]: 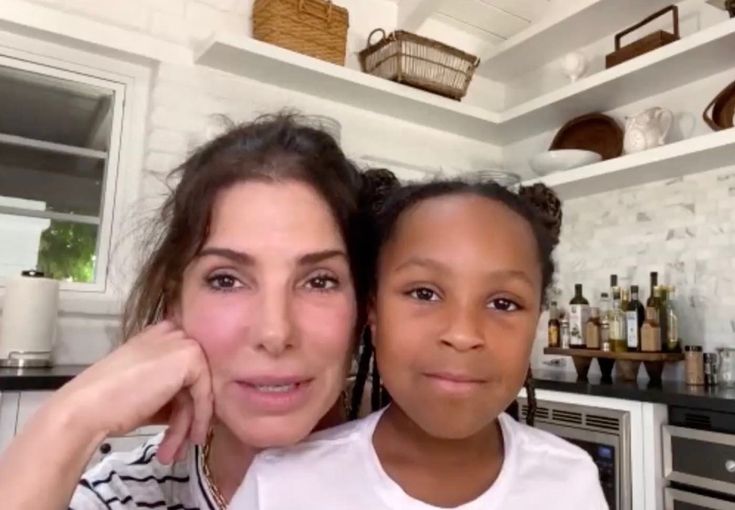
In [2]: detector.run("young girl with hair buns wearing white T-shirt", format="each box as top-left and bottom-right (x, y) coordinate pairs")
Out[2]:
(230, 177), (607, 510)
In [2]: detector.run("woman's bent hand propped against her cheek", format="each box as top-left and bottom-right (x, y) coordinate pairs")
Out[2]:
(47, 321), (213, 463)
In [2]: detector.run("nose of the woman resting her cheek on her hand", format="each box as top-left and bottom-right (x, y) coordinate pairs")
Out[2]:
(256, 291), (295, 356)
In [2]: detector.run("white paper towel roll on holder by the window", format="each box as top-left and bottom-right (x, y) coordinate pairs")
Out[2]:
(0, 271), (59, 365)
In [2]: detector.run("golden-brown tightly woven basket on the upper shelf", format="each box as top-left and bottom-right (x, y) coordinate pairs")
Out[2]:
(253, 0), (349, 65)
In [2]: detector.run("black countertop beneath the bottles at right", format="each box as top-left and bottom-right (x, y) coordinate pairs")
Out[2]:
(533, 370), (735, 413)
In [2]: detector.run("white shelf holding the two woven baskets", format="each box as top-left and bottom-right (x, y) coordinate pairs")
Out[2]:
(195, 34), (499, 142)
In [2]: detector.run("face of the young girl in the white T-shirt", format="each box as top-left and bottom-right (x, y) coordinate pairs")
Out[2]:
(371, 194), (542, 439)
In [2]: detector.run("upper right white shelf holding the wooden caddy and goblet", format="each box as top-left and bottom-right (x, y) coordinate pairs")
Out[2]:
(498, 19), (735, 143)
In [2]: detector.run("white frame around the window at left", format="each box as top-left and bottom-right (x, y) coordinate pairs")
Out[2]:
(0, 31), (152, 315)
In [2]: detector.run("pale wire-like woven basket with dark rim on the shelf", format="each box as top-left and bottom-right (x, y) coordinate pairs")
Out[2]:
(360, 28), (480, 100)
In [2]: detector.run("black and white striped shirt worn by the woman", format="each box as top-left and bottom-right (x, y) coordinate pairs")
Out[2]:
(69, 434), (219, 510)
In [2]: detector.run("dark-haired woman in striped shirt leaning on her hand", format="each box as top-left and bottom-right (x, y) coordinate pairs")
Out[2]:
(0, 116), (370, 510)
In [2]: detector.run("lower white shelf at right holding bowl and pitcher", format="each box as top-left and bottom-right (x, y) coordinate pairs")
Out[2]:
(524, 128), (735, 199)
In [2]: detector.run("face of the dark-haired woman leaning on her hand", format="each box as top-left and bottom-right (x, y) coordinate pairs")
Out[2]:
(179, 181), (357, 447)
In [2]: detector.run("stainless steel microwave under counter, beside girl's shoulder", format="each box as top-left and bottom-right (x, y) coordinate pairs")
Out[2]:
(518, 398), (632, 510)
